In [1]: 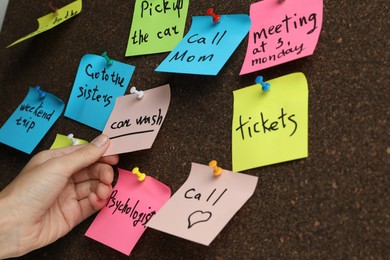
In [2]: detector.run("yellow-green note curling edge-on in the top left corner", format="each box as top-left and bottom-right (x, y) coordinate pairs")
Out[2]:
(7, 0), (82, 48)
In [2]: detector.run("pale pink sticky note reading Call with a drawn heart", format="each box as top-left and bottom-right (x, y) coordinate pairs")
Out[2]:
(147, 163), (258, 246)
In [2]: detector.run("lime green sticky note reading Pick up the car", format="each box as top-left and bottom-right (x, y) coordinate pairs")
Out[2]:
(126, 0), (189, 56)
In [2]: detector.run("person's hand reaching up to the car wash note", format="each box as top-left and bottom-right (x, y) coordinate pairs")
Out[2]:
(0, 135), (119, 259)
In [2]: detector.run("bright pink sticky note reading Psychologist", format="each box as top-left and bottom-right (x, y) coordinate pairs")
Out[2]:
(85, 169), (171, 255)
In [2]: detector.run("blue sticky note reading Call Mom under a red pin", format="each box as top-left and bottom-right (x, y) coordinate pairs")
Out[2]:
(156, 14), (251, 75)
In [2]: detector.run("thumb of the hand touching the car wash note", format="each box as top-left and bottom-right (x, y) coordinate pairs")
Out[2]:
(53, 134), (110, 176)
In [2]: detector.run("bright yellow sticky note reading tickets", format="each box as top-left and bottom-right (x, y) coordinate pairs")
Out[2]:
(232, 72), (308, 171)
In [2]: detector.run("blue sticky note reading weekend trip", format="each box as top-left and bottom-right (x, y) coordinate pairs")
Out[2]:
(0, 87), (65, 154)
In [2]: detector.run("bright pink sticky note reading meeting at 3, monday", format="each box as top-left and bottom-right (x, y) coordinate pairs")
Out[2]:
(240, 0), (323, 75)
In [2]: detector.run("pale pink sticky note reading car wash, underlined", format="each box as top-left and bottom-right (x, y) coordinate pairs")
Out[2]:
(103, 84), (171, 155)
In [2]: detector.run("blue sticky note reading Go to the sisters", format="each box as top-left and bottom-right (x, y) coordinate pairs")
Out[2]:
(65, 54), (135, 131)
